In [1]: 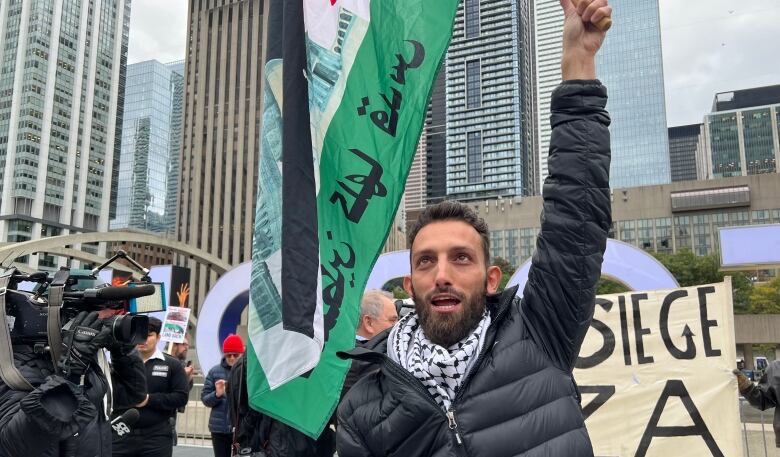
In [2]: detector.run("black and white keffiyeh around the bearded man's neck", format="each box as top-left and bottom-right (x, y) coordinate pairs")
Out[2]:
(387, 310), (490, 411)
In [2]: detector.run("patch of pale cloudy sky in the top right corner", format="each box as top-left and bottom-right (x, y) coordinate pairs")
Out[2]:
(660, 0), (780, 126)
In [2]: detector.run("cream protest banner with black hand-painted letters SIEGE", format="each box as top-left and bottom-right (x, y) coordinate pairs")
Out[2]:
(574, 278), (742, 457)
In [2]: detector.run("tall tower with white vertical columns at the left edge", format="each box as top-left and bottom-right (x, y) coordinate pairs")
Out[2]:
(0, 0), (130, 268)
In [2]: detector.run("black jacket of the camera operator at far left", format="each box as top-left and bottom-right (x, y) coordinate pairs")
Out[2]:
(0, 345), (146, 457)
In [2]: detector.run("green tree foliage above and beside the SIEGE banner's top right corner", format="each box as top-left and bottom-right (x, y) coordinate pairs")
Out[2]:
(653, 250), (753, 314)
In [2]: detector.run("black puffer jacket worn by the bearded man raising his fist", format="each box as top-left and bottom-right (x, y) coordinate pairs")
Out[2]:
(337, 81), (611, 457)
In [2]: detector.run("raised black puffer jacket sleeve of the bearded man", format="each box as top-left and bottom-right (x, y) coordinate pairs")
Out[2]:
(522, 80), (612, 370)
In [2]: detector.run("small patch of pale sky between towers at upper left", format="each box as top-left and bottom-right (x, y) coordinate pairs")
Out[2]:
(127, 0), (188, 63)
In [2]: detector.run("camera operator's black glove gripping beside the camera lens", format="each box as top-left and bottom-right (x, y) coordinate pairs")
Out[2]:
(57, 311), (112, 381)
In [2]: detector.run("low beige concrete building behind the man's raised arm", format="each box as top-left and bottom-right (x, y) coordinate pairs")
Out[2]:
(473, 174), (780, 266)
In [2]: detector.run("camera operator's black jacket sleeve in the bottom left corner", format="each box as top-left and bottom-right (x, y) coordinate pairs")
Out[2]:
(0, 376), (97, 456)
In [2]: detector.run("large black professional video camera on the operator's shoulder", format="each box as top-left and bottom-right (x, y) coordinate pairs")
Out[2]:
(5, 269), (155, 345)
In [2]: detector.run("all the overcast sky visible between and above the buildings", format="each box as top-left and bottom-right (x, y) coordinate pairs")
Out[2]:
(128, 0), (780, 127)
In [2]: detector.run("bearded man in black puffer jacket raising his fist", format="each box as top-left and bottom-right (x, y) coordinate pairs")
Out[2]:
(337, 0), (612, 457)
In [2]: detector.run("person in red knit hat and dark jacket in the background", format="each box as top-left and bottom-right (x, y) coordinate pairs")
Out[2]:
(200, 335), (246, 457)
